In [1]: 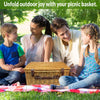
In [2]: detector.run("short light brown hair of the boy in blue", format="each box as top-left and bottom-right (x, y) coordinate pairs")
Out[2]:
(1, 23), (17, 38)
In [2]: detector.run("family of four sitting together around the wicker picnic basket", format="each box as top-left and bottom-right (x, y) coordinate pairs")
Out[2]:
(0, 15), (100, 89)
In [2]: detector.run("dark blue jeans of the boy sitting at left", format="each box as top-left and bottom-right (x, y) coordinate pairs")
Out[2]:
(0, 67), (21, 85)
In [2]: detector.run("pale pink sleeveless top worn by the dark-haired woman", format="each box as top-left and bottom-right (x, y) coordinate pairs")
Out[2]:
(21, 34), (51, 65)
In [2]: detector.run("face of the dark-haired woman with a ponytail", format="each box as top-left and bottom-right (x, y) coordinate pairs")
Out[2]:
(30, 22), (43, 35)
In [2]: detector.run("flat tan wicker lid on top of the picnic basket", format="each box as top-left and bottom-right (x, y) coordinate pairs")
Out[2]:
(25, 62), (70, 70)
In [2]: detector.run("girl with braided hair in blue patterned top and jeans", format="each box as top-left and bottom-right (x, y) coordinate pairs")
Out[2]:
(50, 24), (100, 89)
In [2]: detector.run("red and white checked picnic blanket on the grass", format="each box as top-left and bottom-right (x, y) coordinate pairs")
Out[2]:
(0, 85), (100, 94)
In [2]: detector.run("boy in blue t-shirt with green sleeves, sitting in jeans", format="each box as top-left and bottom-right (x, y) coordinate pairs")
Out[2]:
(0, 23), (25, 85)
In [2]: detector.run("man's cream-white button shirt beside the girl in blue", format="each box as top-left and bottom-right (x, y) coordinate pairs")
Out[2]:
(53, 30), (81, 66)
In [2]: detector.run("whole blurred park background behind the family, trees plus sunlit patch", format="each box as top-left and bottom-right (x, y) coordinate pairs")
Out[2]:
(0, 9), (100, 44)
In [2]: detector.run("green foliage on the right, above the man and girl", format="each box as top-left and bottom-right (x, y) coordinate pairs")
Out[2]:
(38, 9), (100, 26)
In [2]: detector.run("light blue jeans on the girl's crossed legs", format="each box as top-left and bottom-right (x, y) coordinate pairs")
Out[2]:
(59, 73), (100, 89)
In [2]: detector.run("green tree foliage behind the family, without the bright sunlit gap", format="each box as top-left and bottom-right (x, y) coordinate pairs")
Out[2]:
(0, 9), (100, 26)
